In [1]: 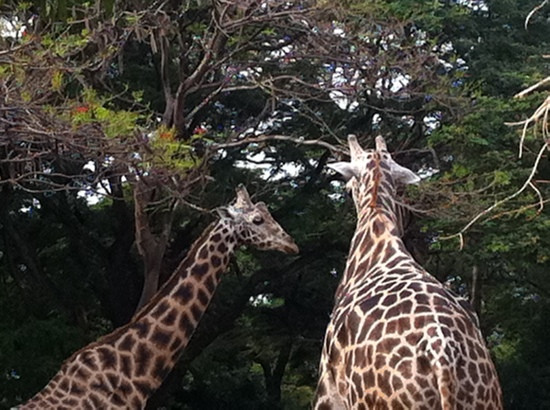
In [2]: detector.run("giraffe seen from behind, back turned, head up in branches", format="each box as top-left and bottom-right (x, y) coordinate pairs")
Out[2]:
(313, 136), (502, 410)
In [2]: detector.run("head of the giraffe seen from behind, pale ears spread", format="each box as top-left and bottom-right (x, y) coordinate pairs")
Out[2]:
(328, 135), (420, 201)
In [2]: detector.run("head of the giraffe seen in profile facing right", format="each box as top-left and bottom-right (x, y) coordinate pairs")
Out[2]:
(216, 184), (298, 253)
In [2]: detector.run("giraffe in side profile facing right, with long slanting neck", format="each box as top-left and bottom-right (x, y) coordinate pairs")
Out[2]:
(19, 185), (298, 410)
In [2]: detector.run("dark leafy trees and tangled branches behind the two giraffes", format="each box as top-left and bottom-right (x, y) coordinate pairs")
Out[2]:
(0, 0), (550, 409)
